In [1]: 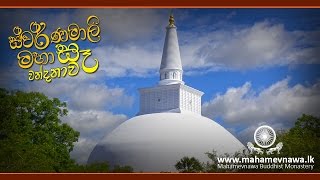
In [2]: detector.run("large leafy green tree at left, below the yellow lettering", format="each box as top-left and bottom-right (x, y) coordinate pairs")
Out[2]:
(0, 89), (79, 172)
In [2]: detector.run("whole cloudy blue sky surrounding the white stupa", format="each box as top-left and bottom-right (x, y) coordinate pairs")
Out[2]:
(0, 9), (320, 162)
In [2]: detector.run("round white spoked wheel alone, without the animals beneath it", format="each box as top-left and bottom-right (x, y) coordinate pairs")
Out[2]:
(253, 125), (277, 148)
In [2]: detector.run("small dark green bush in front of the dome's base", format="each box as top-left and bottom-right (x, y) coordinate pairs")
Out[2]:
(175, 156), (203, 173)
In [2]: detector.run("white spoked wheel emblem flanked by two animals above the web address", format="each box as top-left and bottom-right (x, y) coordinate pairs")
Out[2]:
(247, 125), (283, 155)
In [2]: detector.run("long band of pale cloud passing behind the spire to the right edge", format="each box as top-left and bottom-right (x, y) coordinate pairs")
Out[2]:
(94, 21), (320, 77)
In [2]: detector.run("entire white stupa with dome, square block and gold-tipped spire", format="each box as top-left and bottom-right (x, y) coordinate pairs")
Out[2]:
(88, 15), (244, 172)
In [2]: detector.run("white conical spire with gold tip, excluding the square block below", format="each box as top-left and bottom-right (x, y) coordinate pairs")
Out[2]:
(159, 11), (184, 85)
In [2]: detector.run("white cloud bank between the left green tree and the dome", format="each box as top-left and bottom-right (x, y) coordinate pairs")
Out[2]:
(0, 66), (133, 164)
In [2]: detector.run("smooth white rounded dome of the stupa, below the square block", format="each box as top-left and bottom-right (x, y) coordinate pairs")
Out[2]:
(88, 113), (245, 172)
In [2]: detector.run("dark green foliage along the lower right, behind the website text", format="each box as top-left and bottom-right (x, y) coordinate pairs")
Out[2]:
(176, 114), (320, 172)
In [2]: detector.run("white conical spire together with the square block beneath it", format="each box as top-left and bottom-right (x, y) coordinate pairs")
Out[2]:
(138, 13), (203, 115)
